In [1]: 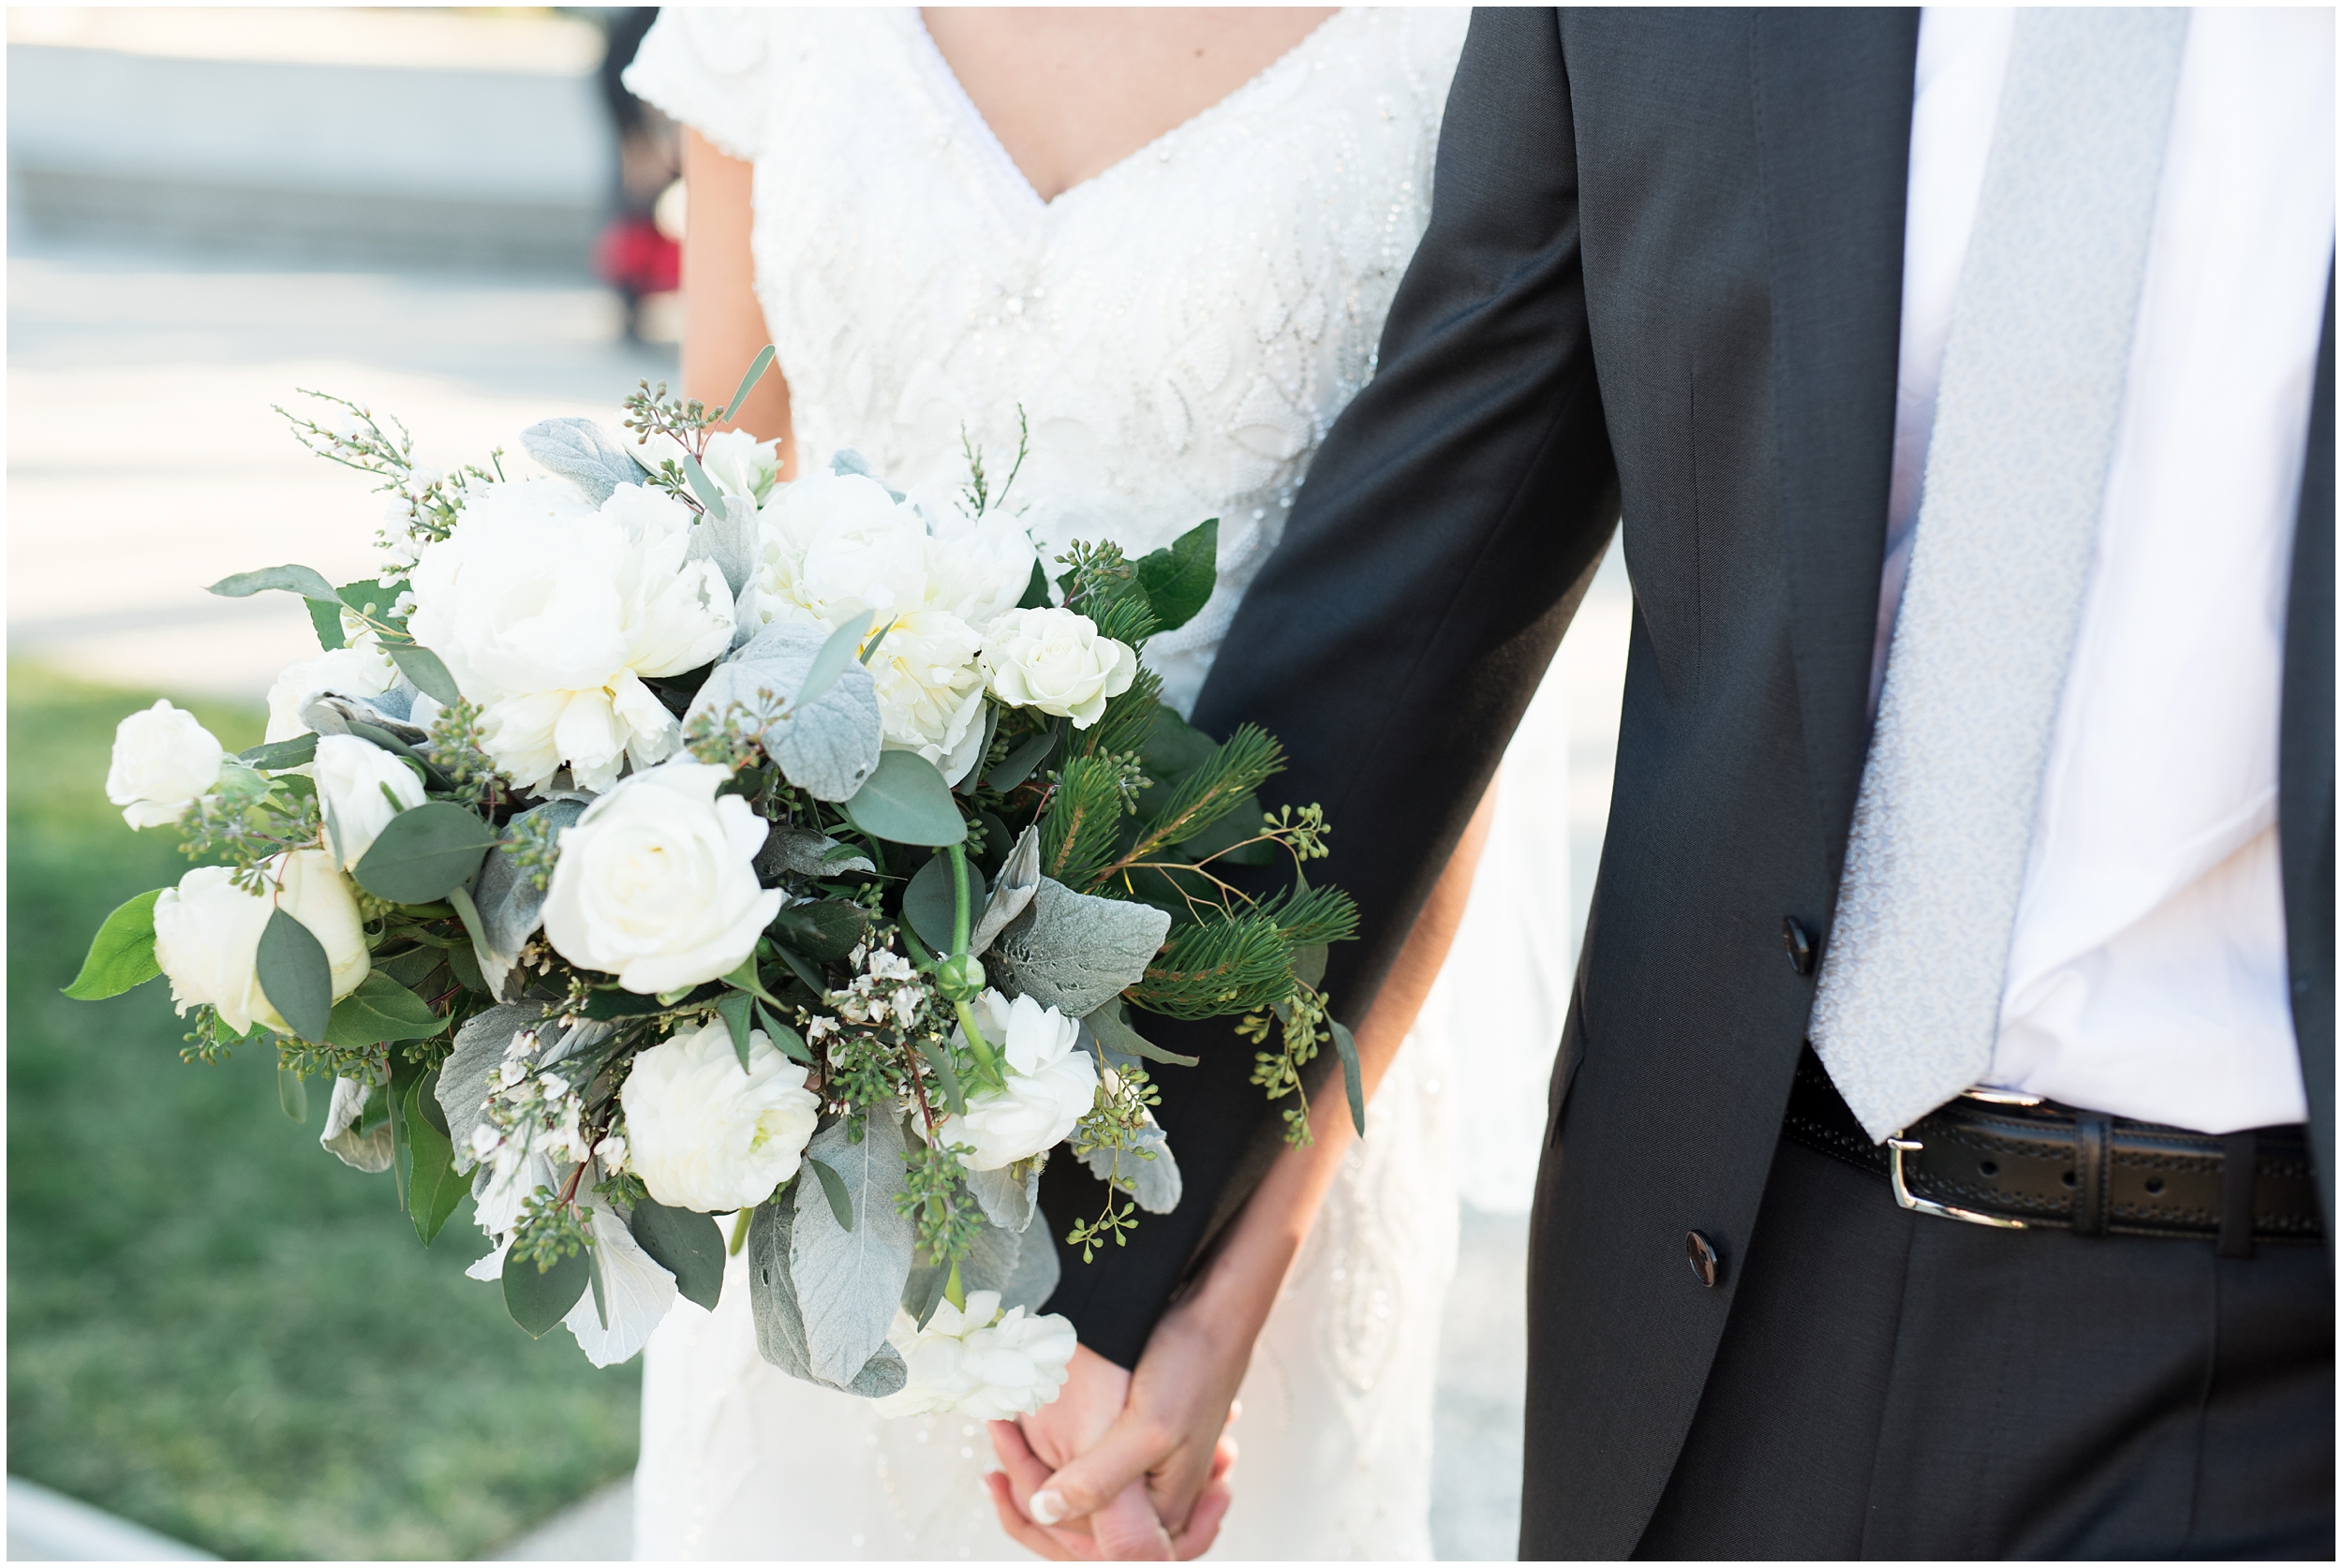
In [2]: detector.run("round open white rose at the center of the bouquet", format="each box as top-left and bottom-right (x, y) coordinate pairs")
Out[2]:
(546, 761), (787, 995)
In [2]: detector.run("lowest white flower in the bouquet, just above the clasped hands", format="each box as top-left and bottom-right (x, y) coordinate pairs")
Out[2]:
(876, 1290), (1075, 1421)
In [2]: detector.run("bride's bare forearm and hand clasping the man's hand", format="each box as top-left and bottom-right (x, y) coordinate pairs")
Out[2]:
(996, 786), (1497, 1557)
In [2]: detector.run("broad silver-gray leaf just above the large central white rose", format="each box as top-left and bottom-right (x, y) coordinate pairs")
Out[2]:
(684, 620), (883, 800)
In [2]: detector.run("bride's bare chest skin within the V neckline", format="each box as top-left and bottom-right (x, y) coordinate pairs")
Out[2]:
(921, 7), (1340, 201)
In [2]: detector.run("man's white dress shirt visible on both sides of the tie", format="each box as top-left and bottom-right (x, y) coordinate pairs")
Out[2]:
(1872, 7), (2335, 1132)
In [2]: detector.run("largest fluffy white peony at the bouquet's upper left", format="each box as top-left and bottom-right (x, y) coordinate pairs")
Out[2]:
(408, 480), (734, 789)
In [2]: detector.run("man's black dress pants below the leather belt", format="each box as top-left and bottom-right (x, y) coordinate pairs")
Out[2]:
(1638, 1142), (2335, 1559)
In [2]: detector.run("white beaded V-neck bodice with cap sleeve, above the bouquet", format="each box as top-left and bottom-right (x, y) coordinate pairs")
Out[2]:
(628, 9), (1466, 707)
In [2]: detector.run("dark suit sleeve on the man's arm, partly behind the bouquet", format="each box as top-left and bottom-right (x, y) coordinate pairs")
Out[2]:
(1043, 9), (1616, 1365)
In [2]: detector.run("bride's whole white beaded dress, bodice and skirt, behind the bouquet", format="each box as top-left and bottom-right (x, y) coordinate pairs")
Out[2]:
(628, 9), (1466, 1559)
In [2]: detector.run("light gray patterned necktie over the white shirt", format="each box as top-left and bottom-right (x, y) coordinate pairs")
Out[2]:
(1811, 9), (2187, 1137)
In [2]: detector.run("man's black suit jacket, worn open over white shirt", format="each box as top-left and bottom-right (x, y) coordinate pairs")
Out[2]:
(1052, 9), (2335, 1557)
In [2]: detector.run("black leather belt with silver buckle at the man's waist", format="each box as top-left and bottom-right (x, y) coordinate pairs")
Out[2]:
(1783, 1046), (2326, 1257)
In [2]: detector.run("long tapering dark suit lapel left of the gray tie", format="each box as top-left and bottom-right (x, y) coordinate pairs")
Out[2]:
(1750, 9), (1919, 898)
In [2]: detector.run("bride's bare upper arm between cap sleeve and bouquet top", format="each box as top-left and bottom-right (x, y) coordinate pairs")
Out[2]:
(684, 128), (796, 480)
